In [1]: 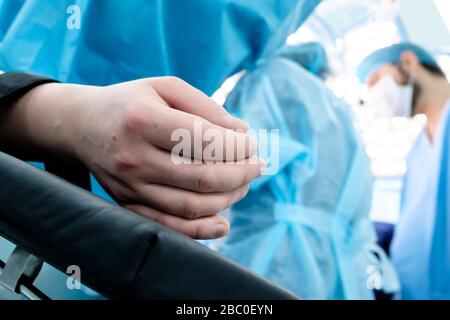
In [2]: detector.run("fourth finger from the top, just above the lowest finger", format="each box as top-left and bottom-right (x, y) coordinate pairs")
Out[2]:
(131, 184), (248, 219)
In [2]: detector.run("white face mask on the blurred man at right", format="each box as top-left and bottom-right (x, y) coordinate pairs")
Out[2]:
(370, 76), (414, 117)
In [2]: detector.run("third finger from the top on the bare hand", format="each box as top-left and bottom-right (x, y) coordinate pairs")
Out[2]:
(140, 148), (265, 193)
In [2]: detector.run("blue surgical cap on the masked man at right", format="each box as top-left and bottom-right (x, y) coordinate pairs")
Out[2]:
(358, 43), (438, 82)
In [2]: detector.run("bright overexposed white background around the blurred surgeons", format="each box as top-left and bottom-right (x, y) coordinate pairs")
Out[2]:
(214, 0), (450, 224)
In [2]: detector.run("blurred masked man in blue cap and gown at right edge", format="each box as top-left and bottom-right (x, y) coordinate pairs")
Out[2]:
(359, 43), (450, 299)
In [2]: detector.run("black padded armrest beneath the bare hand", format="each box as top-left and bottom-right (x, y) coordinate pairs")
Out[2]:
(0, 153), (296, 299)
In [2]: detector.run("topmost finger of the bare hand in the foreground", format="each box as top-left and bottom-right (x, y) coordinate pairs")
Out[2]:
(150, 77), (249, 131)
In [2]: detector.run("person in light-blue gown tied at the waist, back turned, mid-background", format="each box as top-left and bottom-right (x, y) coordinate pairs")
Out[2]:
(218, 43), (398, 299)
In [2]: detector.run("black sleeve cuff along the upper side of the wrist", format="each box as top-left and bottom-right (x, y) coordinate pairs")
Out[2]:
(0, 72), (57, 102)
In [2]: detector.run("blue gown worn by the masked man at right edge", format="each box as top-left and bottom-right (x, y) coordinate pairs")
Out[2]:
(391, 103), (450, 300)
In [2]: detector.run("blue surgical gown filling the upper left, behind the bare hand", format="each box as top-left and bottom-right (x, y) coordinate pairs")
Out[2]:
(0, 0), (321, 298)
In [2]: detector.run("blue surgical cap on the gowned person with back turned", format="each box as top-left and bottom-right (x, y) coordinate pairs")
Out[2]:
(278, 42), (329, 77)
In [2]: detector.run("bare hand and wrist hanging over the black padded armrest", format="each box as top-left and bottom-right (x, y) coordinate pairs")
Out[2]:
(0, 77), (264, 239)
